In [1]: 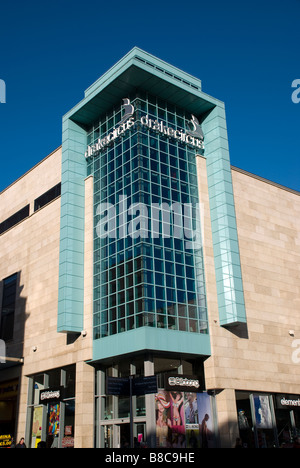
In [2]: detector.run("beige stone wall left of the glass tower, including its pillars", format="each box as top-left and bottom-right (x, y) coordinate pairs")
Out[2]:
(0, 149), (93, 446)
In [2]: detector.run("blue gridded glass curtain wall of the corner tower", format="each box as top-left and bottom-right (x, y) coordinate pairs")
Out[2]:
(88, 92), (208, 339)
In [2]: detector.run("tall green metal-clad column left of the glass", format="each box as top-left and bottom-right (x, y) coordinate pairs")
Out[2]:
(57, 119), (86, 333)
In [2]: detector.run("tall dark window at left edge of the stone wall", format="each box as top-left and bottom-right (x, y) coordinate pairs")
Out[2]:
(0, 274), (17, 341)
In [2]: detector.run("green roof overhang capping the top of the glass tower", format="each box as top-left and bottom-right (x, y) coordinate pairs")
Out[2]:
(64, 47), (224, 127)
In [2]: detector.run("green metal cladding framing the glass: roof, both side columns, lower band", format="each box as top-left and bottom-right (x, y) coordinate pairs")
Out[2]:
(57, 48), (246, 338)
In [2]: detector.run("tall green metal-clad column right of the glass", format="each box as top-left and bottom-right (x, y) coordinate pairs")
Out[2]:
(203, 106), (246, 326)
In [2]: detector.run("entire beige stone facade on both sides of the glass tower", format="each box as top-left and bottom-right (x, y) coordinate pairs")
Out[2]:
(0, 148), (300, 447)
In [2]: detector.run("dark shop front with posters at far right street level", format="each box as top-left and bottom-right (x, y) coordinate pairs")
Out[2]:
(236, 391), (300, 448)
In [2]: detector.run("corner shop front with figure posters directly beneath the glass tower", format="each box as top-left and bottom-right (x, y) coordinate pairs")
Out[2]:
(96, 356), (216, 449)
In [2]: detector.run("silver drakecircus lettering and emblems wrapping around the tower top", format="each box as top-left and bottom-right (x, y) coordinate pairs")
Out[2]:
(85, 98), (204, 158)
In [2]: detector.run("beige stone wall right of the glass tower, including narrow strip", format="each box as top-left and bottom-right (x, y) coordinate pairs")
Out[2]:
(197, 158), (300, 444)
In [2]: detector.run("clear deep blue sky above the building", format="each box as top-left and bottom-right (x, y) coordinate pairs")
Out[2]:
(0, 0), (300, 191)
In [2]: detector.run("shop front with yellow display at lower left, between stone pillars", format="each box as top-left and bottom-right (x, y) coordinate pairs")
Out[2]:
(26, 366), (76, 448)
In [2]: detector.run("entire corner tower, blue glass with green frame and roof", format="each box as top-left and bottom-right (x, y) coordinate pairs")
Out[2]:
(57, 48), (246, 447)
